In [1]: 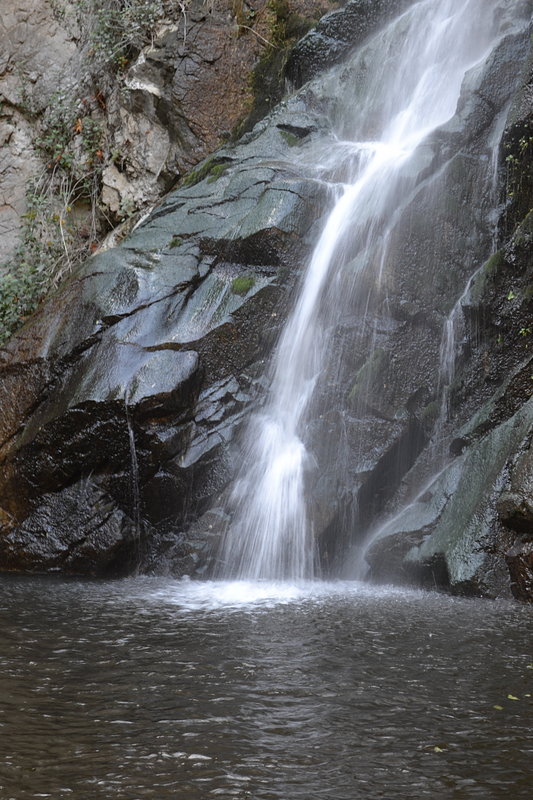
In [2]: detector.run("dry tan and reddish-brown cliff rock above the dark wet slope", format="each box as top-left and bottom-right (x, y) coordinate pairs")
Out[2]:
(0, 0), (331, 270)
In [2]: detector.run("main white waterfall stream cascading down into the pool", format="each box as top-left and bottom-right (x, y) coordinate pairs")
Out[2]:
(221, 0), (500, 580)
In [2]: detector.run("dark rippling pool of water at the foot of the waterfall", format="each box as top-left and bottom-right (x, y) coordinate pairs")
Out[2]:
(0, 576), (533, 800)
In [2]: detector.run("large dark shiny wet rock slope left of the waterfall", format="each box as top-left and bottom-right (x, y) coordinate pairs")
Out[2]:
(0, 89), (327, 574)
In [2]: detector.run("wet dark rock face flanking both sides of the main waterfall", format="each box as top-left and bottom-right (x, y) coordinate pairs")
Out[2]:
(0, 0), (533, 599)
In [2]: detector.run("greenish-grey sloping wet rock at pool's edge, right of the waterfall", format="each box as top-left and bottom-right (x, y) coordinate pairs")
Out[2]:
(367, 376), (533, 599)
